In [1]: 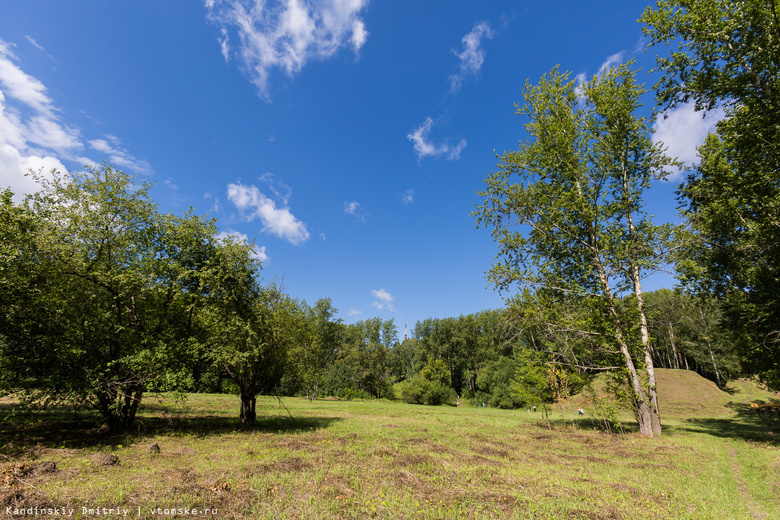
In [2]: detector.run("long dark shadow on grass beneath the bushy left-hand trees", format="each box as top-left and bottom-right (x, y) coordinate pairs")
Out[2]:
(0, 405), (341, 462)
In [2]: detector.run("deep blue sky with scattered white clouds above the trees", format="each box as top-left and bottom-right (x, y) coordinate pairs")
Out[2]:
(0, 0), (717, 334)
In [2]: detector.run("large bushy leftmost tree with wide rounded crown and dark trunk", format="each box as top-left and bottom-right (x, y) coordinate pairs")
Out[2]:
(0, 164), (216, 431)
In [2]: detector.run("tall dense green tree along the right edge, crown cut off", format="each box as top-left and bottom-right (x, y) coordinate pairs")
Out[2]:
(640, 0), (780, 389)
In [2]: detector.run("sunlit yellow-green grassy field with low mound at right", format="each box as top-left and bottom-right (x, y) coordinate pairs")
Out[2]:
(0, 370), (780, 519)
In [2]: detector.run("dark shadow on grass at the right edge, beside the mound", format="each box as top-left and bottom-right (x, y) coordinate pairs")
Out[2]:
(676, 402), (780, 445)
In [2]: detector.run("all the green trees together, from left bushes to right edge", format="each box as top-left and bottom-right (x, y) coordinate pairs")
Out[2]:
(0, 0), (780, 435)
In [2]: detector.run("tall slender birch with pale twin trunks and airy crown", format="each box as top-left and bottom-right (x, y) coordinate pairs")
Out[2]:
(475, 64), (672, 436)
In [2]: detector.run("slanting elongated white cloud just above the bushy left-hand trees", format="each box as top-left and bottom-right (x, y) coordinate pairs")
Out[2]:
(228, 183), (309, 245)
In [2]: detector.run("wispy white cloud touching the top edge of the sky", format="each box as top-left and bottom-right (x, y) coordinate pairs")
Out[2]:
(205, 0), (368, 101)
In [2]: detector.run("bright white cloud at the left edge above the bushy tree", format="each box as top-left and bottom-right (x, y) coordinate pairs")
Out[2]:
(0, 37), (151, 198)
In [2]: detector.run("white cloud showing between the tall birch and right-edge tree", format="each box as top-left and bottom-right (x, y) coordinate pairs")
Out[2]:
(653, 102), (725, 180)
